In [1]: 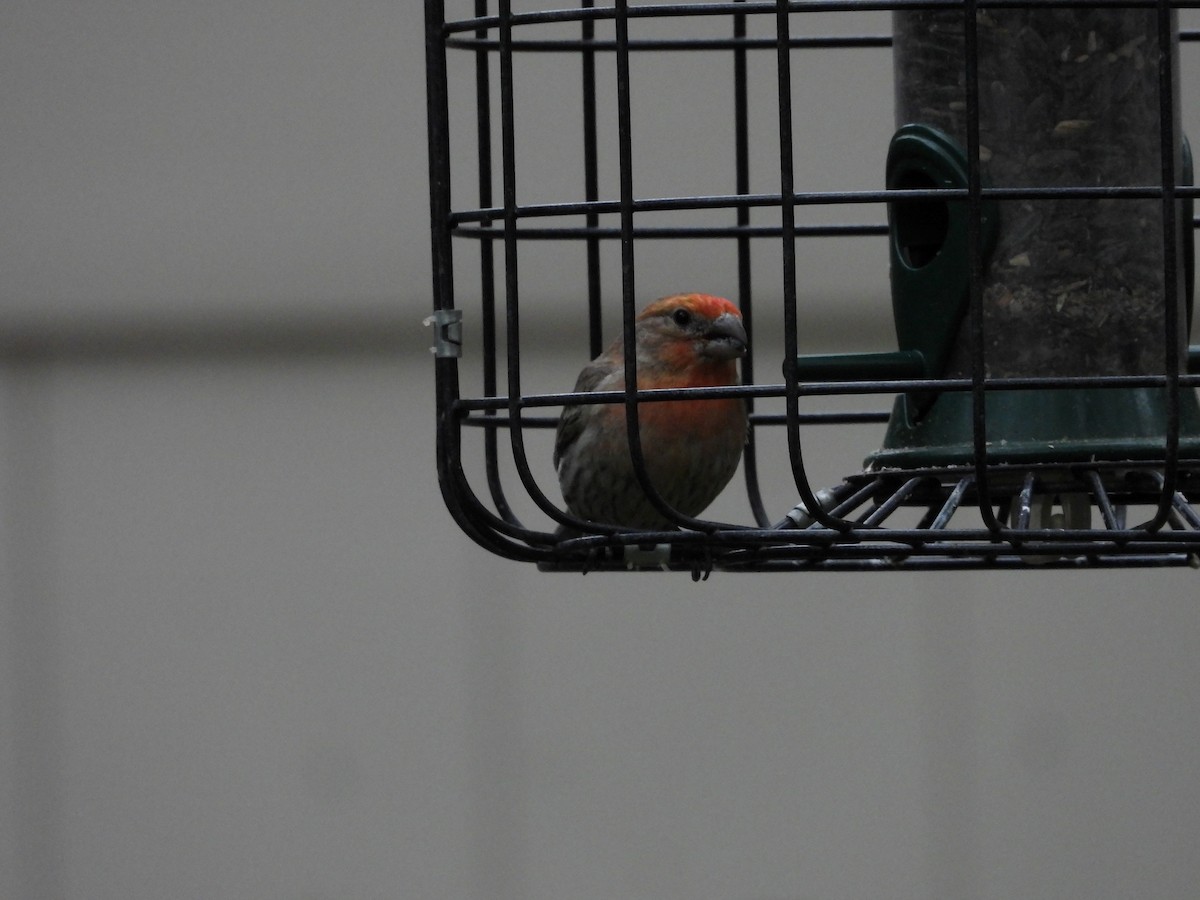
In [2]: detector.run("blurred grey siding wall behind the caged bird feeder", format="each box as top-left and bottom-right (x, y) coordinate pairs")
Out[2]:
(0, 0), (1200, 900)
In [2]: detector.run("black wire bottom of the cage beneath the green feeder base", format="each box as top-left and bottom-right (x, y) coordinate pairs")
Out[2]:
(539, 461), (1200, 578)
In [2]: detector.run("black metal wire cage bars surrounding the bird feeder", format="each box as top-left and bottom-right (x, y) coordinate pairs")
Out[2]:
(425, 0), (1200, 575)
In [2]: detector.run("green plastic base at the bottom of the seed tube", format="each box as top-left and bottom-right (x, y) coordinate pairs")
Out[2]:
(865, 388), (1200, 470)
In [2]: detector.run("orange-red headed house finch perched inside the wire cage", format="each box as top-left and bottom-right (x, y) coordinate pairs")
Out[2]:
(554, 294), (746, 536)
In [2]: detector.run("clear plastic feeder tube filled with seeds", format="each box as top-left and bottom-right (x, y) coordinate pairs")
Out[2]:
(893, 7), (1190, 376)
